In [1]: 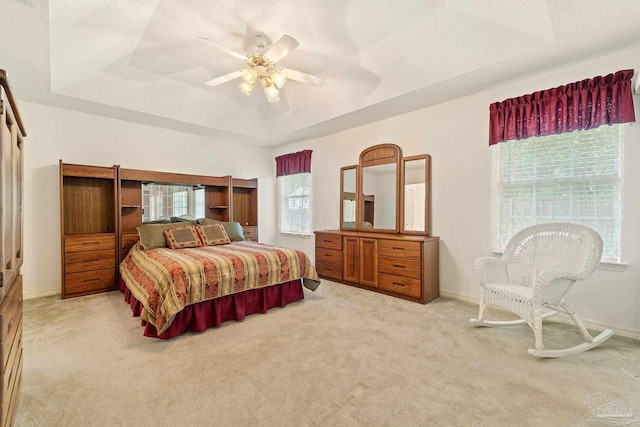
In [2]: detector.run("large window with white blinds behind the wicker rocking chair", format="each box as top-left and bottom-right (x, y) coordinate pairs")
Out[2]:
(496, 125), (622, 262)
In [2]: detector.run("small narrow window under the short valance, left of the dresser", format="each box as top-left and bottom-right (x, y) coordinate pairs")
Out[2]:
(278, 173), (311, 234)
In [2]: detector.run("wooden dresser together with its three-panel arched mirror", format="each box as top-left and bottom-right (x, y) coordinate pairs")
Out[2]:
(315, 144), (439, 304)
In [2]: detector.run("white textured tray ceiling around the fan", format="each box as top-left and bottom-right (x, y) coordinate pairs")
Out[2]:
(0, 0), (640, 146)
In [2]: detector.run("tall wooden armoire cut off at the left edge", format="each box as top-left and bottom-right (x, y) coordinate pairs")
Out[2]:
(0, 70), (26, 427)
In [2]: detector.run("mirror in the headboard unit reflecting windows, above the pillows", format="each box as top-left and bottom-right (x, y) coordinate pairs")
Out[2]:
(142, 183), (205, 222)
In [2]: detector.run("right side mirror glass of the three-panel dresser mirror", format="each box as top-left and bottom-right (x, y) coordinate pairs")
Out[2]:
(404, 158), (427, 232)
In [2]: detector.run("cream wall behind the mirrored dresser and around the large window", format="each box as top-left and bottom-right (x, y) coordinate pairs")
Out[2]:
(274, 44), (640, 336)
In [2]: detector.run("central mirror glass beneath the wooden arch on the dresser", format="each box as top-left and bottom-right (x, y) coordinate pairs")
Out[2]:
(362, 163), (397, 229)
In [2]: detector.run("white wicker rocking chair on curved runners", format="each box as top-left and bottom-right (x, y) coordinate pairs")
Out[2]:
(471, 223), (613, 357)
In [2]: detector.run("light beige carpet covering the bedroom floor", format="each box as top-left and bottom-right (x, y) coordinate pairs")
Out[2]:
(16, 281), (640, 426)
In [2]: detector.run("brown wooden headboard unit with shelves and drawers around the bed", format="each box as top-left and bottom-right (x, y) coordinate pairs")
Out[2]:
(60, 167), (258, 288)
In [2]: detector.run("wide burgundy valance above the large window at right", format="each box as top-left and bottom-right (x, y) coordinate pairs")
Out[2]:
(489, 70), (635, 145)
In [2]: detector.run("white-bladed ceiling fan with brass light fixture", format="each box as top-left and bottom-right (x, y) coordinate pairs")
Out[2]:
(198, 34), (324, 102)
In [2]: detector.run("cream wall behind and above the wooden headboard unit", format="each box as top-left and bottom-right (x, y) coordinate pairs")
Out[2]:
(17, 100), (276, 298)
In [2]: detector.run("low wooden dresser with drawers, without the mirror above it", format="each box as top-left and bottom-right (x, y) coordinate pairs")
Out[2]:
(315, 231), (440, 304)
